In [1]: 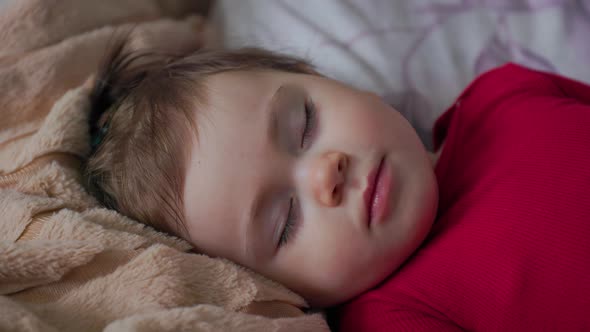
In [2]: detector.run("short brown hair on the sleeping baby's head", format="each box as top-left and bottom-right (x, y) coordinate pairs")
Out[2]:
(83, 38), (316, 239)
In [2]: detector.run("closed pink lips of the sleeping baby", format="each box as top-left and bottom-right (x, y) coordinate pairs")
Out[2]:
(363, 157), (392, 227)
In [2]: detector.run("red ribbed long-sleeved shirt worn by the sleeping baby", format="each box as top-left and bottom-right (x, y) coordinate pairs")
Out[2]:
(338, 64), (590, 332)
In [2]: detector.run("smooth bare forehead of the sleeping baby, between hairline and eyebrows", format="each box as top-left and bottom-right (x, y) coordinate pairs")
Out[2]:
(184, 72), (280, 261)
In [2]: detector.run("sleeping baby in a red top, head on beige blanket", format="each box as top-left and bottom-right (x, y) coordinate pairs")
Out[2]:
(84, 37), (590, 331)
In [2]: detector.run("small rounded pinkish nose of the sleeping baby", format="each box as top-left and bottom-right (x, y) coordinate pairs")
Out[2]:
(312, 152), (348, 206)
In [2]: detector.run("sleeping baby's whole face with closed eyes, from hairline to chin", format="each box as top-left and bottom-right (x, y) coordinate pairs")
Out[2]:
(184, 71), (438, 306)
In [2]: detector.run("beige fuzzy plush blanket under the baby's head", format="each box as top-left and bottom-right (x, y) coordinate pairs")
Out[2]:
(0, 0), (328, 331)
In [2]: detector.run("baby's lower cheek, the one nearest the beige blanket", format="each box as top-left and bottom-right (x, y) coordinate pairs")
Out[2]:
(283, 219), (382, 302)
